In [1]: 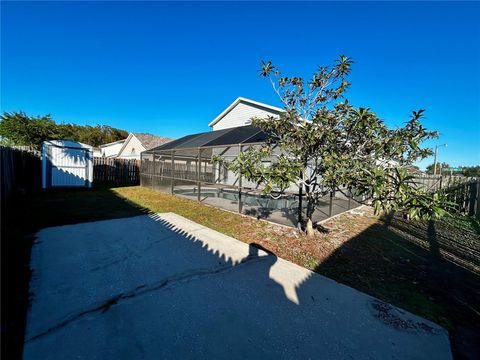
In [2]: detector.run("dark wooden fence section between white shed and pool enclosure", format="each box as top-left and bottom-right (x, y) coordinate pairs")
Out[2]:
(93, 157), (140, 185)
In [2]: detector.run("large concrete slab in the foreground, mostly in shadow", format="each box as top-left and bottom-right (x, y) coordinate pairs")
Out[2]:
(24, 213), (451, 360)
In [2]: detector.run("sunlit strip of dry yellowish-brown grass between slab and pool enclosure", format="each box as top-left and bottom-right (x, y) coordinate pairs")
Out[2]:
(113, 187), (377, 270)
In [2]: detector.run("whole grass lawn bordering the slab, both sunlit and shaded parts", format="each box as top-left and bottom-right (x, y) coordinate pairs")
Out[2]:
(3, 187), (480, 358)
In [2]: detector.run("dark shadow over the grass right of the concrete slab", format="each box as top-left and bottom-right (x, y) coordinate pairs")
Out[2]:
(315, 215), (480, 359)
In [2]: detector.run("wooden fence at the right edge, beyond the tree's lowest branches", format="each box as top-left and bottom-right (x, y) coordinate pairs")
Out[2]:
(415, 176), (480, 219)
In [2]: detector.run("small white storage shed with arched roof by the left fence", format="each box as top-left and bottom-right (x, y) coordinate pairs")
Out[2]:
(42, 140), (93, 189)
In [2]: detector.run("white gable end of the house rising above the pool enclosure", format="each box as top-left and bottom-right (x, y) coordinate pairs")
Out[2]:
(208, 97), (284, 131)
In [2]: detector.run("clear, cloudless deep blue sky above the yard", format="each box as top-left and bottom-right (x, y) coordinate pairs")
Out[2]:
(0, 2), (480, 167)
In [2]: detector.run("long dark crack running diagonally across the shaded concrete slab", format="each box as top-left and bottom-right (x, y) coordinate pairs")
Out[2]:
(25, 255), (269, 343)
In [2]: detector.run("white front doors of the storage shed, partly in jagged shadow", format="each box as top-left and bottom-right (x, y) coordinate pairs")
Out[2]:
(49, 146), (89, 186)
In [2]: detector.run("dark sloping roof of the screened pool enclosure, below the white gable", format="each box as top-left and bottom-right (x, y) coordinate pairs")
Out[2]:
(145, 125), (268, 153)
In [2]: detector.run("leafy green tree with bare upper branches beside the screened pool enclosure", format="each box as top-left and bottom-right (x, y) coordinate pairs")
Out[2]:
(228, 56), (444, 235)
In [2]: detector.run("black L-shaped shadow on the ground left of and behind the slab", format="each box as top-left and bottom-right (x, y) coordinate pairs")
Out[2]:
(1, 187), (149, 359)
